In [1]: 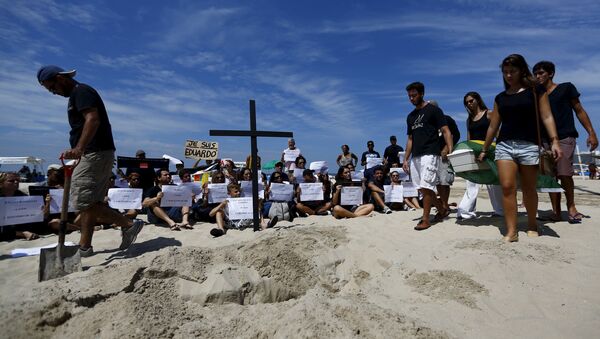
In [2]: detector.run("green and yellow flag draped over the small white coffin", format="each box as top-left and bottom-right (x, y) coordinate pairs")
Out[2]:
(454, 140), (563, 192)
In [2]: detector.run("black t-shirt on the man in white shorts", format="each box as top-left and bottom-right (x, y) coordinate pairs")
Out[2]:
(406, 104), (447, 157)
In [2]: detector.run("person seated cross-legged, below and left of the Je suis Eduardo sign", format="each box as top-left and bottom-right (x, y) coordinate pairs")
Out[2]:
(142, 168), (193, 231)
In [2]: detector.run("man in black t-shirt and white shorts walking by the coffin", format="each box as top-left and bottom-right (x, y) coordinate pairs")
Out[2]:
(402, 82), (453, 231)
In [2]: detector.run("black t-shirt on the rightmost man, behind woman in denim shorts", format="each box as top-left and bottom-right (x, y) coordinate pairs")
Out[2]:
(548, 82), (579, 139)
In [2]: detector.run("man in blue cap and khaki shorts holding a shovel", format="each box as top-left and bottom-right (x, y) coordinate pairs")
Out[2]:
(37, 65), (144, 257)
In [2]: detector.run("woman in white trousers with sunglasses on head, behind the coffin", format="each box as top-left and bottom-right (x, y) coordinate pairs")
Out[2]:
(456, 92), (504, 219)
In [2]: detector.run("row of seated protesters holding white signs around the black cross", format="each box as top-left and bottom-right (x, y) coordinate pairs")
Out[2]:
(132, 156), (420, 236)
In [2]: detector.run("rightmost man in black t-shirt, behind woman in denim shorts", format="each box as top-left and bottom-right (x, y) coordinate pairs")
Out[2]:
(533, 61), (598, 224)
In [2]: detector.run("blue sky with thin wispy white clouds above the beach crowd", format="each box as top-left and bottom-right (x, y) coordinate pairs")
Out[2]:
(0, 0), (600, 173)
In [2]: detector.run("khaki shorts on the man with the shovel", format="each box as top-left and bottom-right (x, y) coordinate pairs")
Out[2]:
(70, 150), (115, 211)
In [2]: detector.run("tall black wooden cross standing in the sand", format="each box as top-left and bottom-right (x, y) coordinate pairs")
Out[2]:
(209, 100), (294, 231)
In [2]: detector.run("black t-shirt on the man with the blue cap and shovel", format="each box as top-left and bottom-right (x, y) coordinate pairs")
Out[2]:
(67, 83), (115, 153)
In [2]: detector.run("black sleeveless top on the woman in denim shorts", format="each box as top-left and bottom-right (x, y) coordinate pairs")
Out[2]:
(495, 86), (546, 144)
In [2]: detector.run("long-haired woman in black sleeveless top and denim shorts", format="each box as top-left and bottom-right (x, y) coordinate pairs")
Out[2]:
(478, 54), (562, 242)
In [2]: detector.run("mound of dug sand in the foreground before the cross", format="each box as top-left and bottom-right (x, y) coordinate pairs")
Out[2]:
(0, 227), (444, 338)
